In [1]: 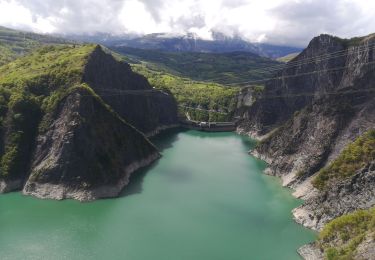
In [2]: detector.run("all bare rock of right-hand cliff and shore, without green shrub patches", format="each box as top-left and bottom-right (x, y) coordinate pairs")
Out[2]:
(238, 35), (375, 258)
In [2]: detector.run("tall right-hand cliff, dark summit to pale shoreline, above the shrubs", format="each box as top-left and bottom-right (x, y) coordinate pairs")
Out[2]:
(239, 35), (375, 185)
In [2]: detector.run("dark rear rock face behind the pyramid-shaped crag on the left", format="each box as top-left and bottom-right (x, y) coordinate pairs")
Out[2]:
(83, 48), (178, 135)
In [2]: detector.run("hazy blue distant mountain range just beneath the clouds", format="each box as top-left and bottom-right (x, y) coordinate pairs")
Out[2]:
(64, 33), (302, 59)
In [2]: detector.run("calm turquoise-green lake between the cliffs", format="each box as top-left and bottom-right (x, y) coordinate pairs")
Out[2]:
(0, 131), (315, 260)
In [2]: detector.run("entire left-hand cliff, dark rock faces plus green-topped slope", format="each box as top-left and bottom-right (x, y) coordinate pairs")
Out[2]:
(0, 45), (177, 200)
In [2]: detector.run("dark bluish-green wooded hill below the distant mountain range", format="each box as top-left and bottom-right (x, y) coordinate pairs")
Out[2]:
(113, 47), (281, 85)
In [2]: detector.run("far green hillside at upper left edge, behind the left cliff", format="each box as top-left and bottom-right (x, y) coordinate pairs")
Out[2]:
(0, 26), (68, 66)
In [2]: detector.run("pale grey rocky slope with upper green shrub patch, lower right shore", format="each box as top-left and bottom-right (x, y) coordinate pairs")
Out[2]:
(294, 130), (375, 229)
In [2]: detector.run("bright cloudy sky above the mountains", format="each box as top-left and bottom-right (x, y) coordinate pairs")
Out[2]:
(0, 0), (375, 46)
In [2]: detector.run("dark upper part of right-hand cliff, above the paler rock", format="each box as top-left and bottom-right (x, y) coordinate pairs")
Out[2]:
(241, 35), (375, 135)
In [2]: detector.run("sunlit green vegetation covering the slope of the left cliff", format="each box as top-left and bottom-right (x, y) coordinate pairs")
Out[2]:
(0, 45), (95, 178)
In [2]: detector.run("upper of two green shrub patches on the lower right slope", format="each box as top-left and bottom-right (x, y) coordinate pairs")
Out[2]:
(312, 129), (375, 190)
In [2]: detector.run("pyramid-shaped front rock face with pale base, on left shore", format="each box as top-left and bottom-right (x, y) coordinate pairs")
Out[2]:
(23, 90), (159, 201)
